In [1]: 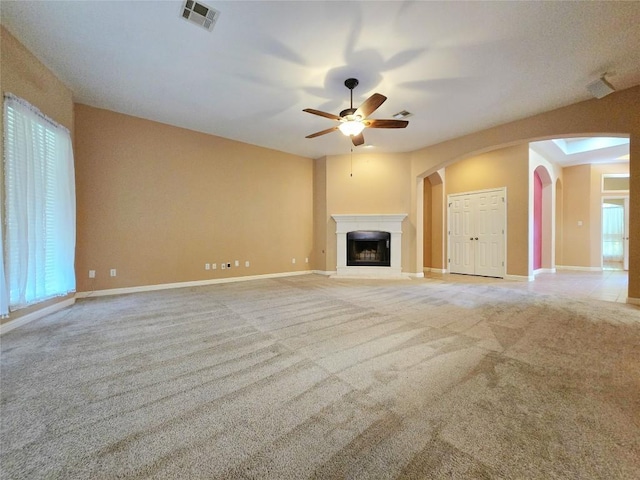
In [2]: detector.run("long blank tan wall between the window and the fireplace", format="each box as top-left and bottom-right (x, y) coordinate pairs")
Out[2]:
(75, 105), (313, 291)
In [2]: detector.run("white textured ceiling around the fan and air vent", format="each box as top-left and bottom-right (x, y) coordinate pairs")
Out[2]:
(1, 0), (640, 158)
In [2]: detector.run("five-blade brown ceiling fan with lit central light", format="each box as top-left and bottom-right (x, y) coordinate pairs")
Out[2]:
(303, 78), (409, 147)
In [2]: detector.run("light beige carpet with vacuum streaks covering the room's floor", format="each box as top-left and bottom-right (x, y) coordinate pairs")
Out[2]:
(0, 275), (640, 480)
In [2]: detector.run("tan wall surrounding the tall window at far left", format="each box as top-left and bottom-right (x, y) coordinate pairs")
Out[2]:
(0, 27), (74, 321)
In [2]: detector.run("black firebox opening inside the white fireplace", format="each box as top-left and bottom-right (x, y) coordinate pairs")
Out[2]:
(347, 230), (391, 267)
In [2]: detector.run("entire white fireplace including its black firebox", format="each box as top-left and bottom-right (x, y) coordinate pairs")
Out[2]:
(331, 213), (407, 278)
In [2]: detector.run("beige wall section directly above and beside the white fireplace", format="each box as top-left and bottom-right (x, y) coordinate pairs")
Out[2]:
(315, 153), (412, 272)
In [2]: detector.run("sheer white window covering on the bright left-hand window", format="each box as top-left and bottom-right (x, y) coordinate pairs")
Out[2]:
(0, 95), (76, 315)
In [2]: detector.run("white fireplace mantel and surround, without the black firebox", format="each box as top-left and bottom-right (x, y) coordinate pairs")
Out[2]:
(331, 213), (407, 278)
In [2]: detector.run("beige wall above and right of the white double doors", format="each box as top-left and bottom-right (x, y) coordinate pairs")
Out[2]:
(445, 144), (529, 276)
